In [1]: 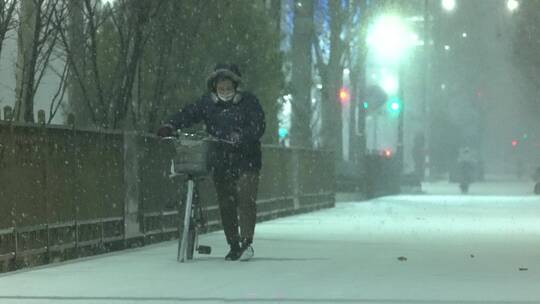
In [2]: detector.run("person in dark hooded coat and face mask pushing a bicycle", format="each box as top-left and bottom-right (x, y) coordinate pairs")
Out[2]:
(157, 63), (265, 260)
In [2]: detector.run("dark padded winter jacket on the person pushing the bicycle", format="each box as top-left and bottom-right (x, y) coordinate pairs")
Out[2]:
(168, 92), (265, 175)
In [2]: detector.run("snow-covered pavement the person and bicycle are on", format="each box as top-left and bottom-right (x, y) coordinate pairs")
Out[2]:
(0, 185), (540, 304)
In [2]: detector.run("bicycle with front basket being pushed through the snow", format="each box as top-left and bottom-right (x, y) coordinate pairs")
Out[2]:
(163, 133), (220, 263)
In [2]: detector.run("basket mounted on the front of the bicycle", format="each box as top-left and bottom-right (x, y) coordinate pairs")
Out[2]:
(173, 137), (212, 175)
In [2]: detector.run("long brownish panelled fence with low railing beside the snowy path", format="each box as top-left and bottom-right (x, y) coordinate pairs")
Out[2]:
(0, 121), (335, 271)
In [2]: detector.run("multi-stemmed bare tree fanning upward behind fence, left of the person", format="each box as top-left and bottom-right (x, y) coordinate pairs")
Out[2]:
(55, 0), (162, 128)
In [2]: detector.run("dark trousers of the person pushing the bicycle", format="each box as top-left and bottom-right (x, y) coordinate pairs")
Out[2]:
(214, 171), (259, 244)
